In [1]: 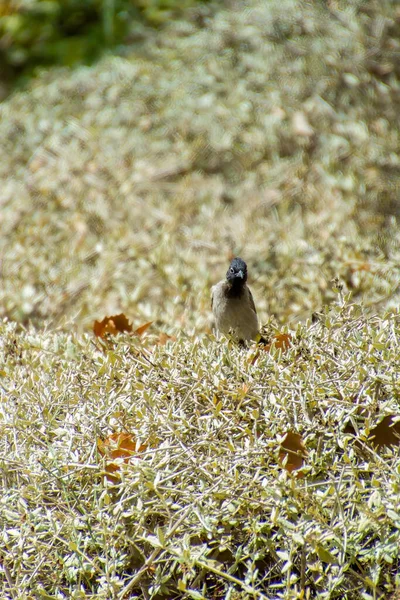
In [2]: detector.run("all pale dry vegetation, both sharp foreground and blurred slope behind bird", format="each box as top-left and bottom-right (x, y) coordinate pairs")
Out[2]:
(0, 0), (400, 600)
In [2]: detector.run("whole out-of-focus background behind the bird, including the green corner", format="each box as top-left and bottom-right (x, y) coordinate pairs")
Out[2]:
(0, 0), (400, 335)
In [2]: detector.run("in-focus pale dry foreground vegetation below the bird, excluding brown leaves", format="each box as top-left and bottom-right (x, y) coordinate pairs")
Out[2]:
(1, 305), (400, 600)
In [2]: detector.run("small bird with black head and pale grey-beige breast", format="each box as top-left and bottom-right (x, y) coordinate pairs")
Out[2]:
(211, 258), (258, 344)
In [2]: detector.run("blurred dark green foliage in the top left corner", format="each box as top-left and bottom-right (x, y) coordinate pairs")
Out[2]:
(0, 0), (206, 99)
